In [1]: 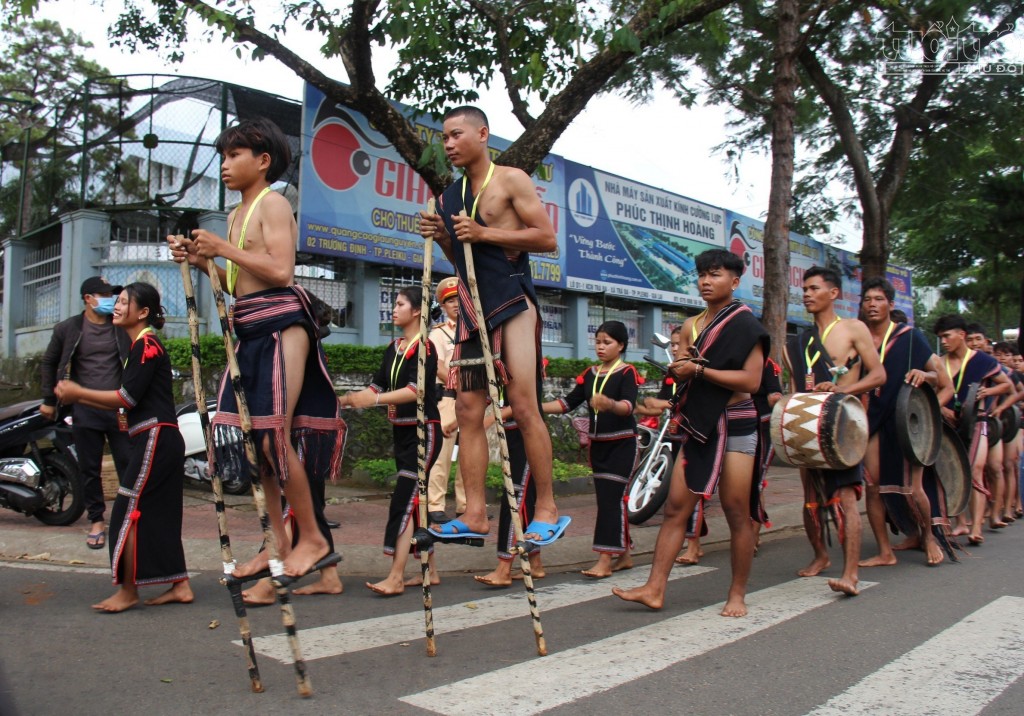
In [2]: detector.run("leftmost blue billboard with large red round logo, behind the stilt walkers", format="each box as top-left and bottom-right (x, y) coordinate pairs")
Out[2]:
(299, 84), (565, 287)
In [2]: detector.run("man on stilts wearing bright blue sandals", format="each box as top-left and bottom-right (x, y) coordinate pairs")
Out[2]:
(420, 107), (566, 544)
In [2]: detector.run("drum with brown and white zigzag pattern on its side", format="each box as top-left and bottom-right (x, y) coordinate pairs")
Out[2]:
(771, 392), (867, 470)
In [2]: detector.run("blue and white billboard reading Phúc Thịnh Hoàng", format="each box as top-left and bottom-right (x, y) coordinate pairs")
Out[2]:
(564, 161), (725, 307)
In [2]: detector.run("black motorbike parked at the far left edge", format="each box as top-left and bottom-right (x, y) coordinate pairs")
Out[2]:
(0, 401), (85, 527)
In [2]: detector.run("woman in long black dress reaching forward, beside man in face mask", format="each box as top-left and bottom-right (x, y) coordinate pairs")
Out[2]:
(56, 283), (193, 612)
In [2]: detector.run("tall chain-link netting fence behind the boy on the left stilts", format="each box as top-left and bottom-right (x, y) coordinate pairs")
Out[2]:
(0, 75), (302, 237)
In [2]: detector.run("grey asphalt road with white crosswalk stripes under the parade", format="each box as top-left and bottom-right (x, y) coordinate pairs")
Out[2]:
(0, 522), (1024, 716)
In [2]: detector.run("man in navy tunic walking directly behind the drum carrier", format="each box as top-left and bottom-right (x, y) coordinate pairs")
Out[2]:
(860, 278), (953, 566)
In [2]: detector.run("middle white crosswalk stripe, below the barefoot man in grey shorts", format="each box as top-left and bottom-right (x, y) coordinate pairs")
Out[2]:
(401, 578), (876, 716)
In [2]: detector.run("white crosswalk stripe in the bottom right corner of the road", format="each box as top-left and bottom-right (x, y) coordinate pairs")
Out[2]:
(808, 596), (1024, 716)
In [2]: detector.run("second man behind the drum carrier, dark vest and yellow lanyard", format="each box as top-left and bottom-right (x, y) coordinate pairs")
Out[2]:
(935, 314), (1013, 545)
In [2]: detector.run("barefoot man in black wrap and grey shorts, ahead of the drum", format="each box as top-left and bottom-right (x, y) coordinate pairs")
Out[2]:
(611, 249), (769, 617)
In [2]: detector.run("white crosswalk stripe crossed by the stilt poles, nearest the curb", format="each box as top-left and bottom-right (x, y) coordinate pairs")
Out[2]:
(243, 565), (715, 664)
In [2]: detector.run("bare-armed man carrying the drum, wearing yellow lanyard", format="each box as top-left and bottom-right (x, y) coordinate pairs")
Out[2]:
(783, 266), (886, 596)
